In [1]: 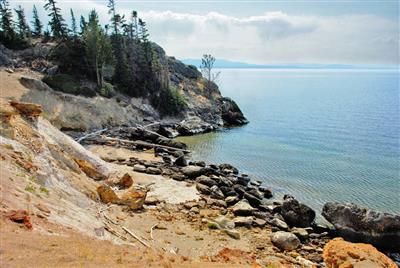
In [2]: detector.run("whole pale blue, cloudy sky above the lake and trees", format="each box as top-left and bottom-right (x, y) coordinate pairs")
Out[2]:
(10, 0), (400, 65)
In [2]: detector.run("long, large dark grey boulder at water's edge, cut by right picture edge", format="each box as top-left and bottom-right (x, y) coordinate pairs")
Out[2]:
(322, 202), (400, 249)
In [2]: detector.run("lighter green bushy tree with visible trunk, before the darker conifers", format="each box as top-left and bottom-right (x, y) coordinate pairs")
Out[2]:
(83, 10), (113, 88)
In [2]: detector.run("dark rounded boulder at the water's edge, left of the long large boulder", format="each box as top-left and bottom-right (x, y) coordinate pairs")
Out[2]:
(280, 196), (315, 228)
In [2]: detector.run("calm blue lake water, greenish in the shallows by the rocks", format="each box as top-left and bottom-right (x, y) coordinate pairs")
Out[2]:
(180, 69), (400, 214)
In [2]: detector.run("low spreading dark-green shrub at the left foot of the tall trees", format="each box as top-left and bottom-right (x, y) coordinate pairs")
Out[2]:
(43, 74), (96, 97)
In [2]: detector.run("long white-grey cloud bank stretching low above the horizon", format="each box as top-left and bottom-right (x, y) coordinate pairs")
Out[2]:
(10, 1), (399, 64)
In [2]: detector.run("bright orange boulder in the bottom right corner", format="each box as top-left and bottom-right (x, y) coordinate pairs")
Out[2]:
(323, 238), (397, 268)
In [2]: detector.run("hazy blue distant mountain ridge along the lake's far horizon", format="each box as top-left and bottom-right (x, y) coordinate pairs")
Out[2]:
(182, 59), (399, 69)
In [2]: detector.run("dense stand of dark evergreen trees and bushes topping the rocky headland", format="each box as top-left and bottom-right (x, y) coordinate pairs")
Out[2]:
(0, 0), (192, 115)
